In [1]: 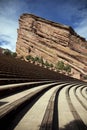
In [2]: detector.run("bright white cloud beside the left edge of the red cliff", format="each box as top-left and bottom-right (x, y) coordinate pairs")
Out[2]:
(0, 16), (18, 51)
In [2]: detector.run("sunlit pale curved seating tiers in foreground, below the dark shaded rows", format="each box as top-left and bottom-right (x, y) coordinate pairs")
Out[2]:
(0, 80), (87, 130)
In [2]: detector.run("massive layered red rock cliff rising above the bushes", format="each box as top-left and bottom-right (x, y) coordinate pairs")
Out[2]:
(16, 14), (87, 75)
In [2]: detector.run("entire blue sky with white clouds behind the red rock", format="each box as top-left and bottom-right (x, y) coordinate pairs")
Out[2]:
(0, 0), (87, 51)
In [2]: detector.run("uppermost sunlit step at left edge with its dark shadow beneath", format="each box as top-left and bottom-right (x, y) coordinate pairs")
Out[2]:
(0, 81), (53, 98)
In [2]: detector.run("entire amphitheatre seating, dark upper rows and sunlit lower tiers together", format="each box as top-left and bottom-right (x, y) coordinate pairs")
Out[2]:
(0, 56), (87, 130)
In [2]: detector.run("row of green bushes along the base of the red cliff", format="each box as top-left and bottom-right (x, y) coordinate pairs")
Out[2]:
(3, 49), (71, 75)
